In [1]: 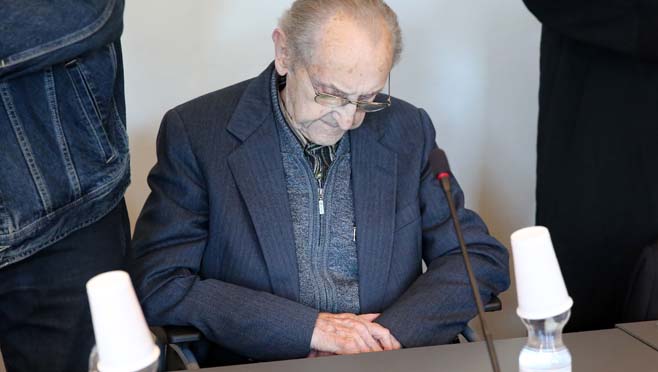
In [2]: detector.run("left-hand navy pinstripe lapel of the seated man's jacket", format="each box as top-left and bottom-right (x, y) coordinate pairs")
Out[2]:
(227, 66), (299, 301)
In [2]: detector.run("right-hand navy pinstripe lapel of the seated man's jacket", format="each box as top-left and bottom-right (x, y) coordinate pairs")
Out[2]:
(350, 115), (397, 313)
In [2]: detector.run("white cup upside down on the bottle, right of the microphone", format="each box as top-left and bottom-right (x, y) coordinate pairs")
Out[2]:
(511, 226), (573, 319)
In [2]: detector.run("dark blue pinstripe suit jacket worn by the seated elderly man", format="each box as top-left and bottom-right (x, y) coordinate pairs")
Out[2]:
(132, 65), (509, 360)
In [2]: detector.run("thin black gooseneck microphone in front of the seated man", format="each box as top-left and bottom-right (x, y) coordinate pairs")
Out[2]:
(429, 148), (500, 372)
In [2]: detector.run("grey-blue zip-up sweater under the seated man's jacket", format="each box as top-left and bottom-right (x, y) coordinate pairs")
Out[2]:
(272, 73), (360, 313)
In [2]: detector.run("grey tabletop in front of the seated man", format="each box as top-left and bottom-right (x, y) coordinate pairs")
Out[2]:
(195, 329), (658, 372)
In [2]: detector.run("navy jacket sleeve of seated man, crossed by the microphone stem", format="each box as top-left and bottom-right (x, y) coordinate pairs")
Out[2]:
(376, 110), (509, 347)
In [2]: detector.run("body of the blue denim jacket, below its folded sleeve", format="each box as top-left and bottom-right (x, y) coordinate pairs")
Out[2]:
(0, 44), (130, 262)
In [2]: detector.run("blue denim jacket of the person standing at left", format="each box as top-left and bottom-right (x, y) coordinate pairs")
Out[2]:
(0, 0), (130, 268)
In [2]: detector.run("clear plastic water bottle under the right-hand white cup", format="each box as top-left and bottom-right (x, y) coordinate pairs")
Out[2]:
(519, 310), (571, 372)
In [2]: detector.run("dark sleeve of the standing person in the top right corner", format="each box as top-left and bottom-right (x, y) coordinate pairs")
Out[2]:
(523, 0), (658, 61)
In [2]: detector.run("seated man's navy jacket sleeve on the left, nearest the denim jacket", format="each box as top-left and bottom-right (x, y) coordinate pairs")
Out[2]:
(131, 110), (318, 360)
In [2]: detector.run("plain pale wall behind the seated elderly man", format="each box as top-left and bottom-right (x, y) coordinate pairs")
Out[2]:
(122, 0), (540, 338)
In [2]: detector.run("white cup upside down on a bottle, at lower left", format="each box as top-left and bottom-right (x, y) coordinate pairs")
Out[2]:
(87, 271), (160, 372)
